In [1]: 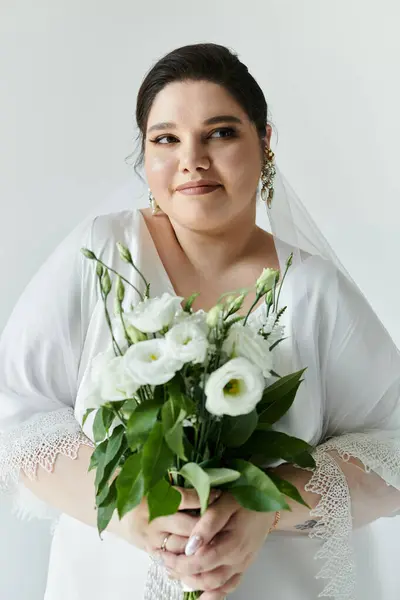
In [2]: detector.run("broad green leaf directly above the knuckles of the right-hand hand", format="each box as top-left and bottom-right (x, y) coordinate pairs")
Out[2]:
(229, 459), (289, 512)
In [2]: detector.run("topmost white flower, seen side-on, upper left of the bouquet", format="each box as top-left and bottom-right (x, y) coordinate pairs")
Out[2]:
(125, 293), (183, 333)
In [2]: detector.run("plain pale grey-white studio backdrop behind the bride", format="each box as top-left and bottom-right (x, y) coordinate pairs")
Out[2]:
(0, 0), (400, 600)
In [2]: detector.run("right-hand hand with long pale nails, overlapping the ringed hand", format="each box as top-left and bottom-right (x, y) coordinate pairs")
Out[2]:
(160, 493), (275, 600)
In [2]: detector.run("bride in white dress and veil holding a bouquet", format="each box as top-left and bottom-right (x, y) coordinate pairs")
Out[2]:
(0, 44), (400, 600)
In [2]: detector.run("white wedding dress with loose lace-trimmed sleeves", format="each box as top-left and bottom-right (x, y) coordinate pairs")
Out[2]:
(0, 210), (400, 600)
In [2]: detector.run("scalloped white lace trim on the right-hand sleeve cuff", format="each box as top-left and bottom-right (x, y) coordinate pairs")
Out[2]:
(305, 433), (400, 600)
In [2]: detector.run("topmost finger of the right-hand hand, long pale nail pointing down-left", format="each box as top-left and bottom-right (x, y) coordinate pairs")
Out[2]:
(186, 494), (239, 556)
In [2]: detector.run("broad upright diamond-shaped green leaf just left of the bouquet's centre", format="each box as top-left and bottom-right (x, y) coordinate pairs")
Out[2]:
(142, 421), (175, 493)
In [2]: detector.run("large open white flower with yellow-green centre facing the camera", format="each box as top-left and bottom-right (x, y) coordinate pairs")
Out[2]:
(204, 358), (265, 417)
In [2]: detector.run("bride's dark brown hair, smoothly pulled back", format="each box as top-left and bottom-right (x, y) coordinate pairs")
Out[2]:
(131, 44), (268, 169)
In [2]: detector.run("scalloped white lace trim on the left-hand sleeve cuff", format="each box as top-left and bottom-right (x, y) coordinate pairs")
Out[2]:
(0, 408), (93, 517)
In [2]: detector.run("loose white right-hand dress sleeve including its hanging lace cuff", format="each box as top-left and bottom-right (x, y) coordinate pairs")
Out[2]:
(306, 264), (400, 600)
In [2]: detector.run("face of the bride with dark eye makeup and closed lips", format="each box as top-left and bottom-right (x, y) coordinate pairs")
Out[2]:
(145, 81), (270, 231)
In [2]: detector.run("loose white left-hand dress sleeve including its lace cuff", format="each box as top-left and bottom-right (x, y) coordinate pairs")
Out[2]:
(0, 222), (96, 517)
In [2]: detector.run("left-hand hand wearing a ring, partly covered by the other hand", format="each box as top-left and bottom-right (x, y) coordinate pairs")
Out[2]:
(109, 487), (220, 554)
